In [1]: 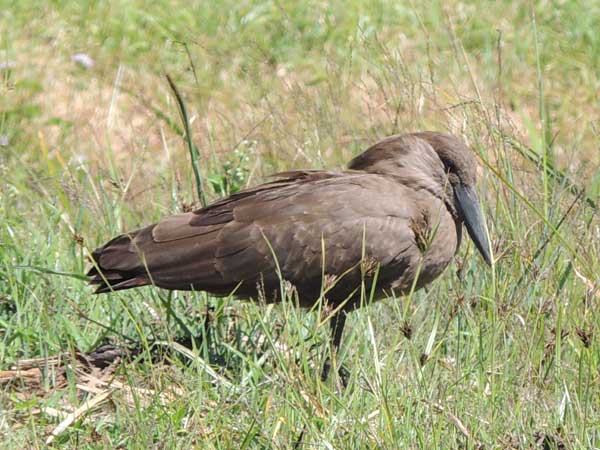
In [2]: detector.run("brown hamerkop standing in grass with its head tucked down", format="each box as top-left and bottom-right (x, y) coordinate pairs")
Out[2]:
(88, 132), (491, 379)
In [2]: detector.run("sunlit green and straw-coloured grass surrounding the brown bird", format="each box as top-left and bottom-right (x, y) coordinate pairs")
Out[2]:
(0, 0), (600, 449)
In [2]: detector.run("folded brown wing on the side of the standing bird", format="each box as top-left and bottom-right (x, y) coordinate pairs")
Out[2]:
(92, 172), (416, 292)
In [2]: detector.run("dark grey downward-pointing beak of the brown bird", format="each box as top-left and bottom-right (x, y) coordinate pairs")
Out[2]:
(454, 185), (492, 266)
